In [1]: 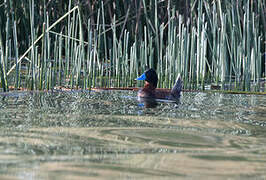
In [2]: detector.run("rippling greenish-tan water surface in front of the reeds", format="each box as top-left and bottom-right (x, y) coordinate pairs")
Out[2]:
(0, 91), (266, 180)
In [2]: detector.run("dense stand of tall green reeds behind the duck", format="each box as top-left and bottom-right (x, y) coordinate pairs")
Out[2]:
(0, 0), (266, 95)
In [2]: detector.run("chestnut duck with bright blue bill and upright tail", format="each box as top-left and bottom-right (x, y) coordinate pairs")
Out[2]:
(135, 68), (183, 100)
